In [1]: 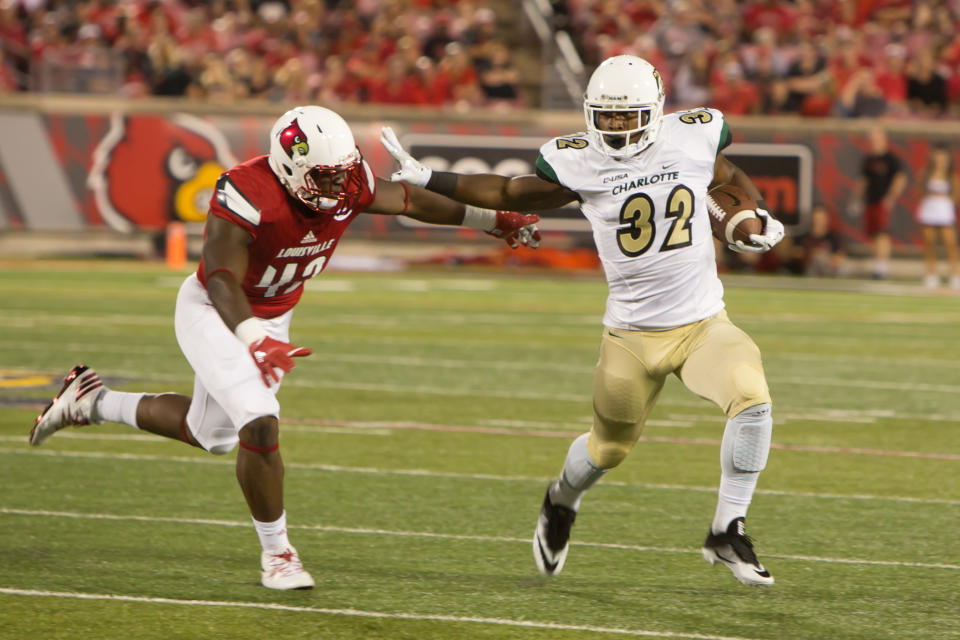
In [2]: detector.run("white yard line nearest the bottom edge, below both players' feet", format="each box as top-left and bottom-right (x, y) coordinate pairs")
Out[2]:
(0, 587), (750, 640)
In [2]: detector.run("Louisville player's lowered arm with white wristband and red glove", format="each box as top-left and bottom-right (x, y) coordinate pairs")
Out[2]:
(203, 215), (311, 387)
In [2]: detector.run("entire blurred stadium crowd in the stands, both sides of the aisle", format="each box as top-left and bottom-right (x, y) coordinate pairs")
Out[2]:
(0, 0), (960, 118)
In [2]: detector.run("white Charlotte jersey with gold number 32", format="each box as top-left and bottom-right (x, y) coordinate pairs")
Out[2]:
(537, 109), (730, 331)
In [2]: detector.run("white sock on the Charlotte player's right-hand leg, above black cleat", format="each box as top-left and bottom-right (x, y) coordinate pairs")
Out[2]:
(710, 404), (773, 533)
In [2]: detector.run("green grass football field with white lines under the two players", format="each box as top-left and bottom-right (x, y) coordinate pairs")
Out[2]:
(0, 261), (960, 640)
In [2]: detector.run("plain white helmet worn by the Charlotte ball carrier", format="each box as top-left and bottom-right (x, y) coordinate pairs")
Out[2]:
(583, 56), (664, 158)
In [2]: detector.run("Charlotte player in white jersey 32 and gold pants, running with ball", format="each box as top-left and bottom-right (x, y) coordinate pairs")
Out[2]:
(381, 56), (783, 585)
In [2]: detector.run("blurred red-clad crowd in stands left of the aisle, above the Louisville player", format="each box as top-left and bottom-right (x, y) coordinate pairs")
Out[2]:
(0, 0), (520, 108)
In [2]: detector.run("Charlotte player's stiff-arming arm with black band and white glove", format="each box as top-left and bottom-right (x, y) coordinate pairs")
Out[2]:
(380, 127), (578, 211)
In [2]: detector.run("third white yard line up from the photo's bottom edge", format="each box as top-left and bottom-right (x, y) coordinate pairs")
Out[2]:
(0, 450), (960, 506)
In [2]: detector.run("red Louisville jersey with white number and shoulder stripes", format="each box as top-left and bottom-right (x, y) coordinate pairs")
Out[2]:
(197, 156), (376, 318)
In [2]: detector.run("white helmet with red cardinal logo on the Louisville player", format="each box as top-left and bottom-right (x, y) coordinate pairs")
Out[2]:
(269, 106), (369, 215)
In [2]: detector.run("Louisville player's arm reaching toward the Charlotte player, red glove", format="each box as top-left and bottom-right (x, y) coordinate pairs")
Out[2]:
(367, 178), (540, 249)
